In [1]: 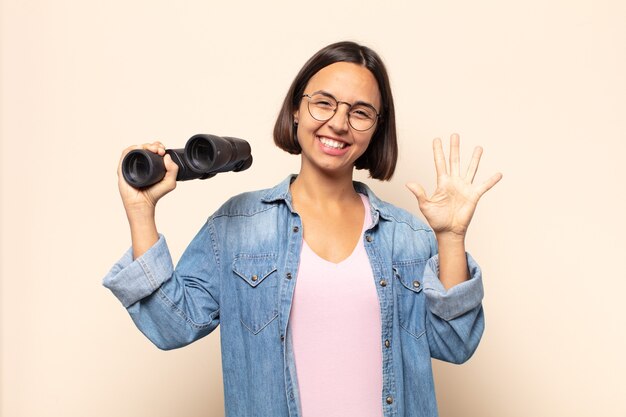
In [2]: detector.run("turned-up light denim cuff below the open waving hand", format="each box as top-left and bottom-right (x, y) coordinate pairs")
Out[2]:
(424, 252), (484, 321)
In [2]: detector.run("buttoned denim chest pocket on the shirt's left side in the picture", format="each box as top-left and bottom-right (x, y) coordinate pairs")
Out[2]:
(233, 254), (278, 334)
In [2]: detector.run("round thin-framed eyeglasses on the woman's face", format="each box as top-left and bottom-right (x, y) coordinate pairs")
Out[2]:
(302, 92), (380, 132)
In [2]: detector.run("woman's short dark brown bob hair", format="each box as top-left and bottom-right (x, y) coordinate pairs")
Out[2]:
(274, 42), (398, 180)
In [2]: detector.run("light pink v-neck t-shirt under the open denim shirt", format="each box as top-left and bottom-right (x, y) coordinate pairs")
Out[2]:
(289, 194), (383, 417)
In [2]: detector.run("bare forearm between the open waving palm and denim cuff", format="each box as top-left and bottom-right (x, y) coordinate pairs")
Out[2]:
(436, 234), (470, 290)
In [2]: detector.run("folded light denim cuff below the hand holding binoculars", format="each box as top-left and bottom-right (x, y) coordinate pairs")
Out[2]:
(102, 234), (174, 308)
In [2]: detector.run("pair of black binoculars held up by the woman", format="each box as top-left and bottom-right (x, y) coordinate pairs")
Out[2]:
(122, 134), (252, 188)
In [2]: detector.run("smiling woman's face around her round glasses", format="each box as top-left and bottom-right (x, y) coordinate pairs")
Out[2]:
(294, 62), (381, 176)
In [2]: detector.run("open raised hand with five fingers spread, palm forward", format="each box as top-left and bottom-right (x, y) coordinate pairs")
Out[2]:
(407, 134), (502, 238)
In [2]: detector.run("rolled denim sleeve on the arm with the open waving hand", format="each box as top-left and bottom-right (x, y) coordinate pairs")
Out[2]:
(424, 250), (485, 363)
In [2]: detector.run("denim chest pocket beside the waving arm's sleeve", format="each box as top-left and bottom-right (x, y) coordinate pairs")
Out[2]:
(393, 260), (426, 338)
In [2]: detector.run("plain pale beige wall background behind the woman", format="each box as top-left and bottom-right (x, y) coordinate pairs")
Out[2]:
(0, 0), (626, 417)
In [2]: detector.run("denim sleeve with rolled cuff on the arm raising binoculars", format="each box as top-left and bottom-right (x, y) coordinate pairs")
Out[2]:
(103, 222), (220, 349)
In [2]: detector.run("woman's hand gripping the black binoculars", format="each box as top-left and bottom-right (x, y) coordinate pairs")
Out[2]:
(117, 142), (178, 215)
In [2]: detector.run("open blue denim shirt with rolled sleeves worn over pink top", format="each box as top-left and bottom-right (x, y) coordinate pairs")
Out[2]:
(103, 176), (484, 417)
